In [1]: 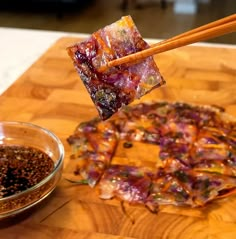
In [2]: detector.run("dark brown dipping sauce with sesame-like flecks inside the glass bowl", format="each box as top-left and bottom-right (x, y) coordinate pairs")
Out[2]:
(0, 145), (54, 198)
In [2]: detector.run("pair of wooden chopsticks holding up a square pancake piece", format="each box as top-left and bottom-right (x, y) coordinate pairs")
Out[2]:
(99, 14), (236, 72)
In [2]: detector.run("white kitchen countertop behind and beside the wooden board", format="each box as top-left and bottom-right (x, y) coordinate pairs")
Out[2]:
(0, 27), (236, 94)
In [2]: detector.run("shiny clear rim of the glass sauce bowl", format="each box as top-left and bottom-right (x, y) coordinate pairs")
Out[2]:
(0, 121), (65, 203)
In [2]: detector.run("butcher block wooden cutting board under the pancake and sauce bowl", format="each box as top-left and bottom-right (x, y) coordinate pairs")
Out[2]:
(0, 37), (236, 239)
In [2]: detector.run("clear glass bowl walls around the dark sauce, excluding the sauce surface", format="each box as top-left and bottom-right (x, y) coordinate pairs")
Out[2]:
(0, 122), (64, 219)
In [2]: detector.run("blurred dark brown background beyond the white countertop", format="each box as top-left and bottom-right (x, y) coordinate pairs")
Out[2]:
(0, 0), (236, 44)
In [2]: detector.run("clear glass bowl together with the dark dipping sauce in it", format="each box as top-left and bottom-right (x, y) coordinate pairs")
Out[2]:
(0, 122), (64, 219)
